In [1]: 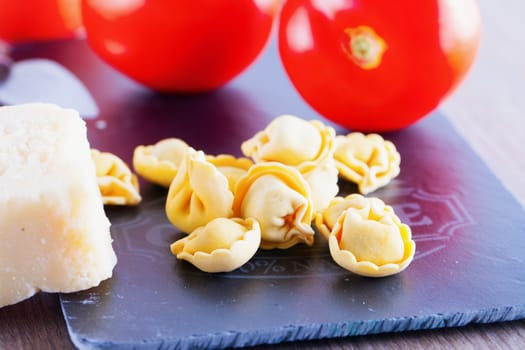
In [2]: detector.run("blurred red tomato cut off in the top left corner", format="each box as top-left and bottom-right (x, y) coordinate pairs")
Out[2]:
(0, 0), (80, 43)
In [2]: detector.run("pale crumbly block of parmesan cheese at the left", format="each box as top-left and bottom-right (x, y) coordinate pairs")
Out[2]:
(0, 104), (117, 307)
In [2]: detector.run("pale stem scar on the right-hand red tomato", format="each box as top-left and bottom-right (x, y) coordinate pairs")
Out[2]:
(343, 26), (387, 69)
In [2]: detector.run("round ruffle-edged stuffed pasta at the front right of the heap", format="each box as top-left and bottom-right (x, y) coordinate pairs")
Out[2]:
(328, 198), (416, 277)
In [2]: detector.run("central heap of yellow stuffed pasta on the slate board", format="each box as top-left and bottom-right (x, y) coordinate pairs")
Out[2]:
(96, 115), (415, 277)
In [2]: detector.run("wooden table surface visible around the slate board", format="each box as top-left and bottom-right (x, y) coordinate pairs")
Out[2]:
(0, 0), (525, 349)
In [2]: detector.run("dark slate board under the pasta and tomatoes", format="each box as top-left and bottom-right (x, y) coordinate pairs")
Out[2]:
(14, 41), (525, 349)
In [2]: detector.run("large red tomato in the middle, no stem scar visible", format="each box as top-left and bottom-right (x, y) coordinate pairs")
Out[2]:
(82, 0), (278, 92)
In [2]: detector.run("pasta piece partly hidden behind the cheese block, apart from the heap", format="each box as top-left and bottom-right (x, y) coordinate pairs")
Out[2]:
(91, 149), (142, 205)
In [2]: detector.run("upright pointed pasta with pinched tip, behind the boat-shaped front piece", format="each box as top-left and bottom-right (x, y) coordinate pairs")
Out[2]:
(166, 147), (233, 233)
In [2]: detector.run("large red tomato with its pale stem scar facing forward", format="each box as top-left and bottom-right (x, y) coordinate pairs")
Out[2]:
(279, 0), (481, 131)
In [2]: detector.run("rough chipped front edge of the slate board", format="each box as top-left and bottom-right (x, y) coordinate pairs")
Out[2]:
(61, 298), (525, 350)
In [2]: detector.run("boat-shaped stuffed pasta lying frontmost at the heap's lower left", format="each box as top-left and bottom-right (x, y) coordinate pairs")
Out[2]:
(171, 218), (261, 272)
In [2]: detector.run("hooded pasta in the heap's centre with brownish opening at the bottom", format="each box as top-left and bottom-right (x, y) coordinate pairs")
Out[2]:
(233, 162), (314, 249)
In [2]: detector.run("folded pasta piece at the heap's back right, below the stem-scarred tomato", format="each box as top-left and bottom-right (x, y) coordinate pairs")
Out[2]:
(334, 132), (401, 194)
